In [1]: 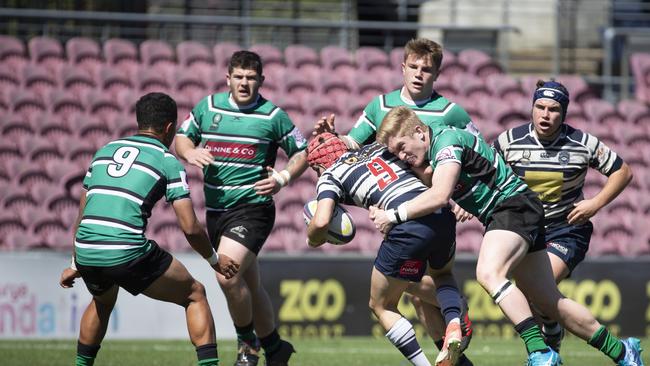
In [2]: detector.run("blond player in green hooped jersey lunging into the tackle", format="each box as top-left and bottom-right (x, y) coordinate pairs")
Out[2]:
(371, 107), (642, 366)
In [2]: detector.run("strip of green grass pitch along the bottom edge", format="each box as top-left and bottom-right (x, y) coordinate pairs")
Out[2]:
(0, 337), (650, 366)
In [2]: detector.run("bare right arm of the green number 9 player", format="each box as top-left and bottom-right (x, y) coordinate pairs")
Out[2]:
(172, 198), (239, 278)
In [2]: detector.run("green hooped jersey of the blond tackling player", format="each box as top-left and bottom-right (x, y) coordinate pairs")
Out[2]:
(429, 127), (528, 224)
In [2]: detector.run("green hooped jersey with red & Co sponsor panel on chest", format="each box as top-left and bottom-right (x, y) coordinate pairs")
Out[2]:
(178, 92), (307, 211)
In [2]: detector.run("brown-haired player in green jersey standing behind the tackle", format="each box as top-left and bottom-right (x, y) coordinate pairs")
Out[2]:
(313, 38), (480, 366)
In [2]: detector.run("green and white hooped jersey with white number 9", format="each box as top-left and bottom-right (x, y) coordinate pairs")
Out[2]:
(75, 135), (190, 267)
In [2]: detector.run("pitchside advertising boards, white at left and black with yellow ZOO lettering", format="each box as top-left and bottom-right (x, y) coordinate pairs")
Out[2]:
(0, 252), (650, 339)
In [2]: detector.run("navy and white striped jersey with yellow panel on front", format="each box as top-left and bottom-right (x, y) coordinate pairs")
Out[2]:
(494, 123), (623, 228)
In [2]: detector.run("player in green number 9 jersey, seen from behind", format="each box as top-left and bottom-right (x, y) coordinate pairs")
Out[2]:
(60, 93), (239, 366)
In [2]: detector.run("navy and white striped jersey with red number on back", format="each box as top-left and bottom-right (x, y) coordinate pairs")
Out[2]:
(316, 143), (427, 209)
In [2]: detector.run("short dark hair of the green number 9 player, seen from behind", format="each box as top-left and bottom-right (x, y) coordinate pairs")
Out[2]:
(135, 93), (178, 133)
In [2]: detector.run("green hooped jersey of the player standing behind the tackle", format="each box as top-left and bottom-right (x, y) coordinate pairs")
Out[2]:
(348, 89), (480, 146)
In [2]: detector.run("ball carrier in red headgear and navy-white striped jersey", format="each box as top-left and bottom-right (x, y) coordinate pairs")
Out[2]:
(307, 132), (471, 366)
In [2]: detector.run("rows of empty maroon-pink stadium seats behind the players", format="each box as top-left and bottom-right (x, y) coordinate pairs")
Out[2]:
(0, 36), (650, 255)
